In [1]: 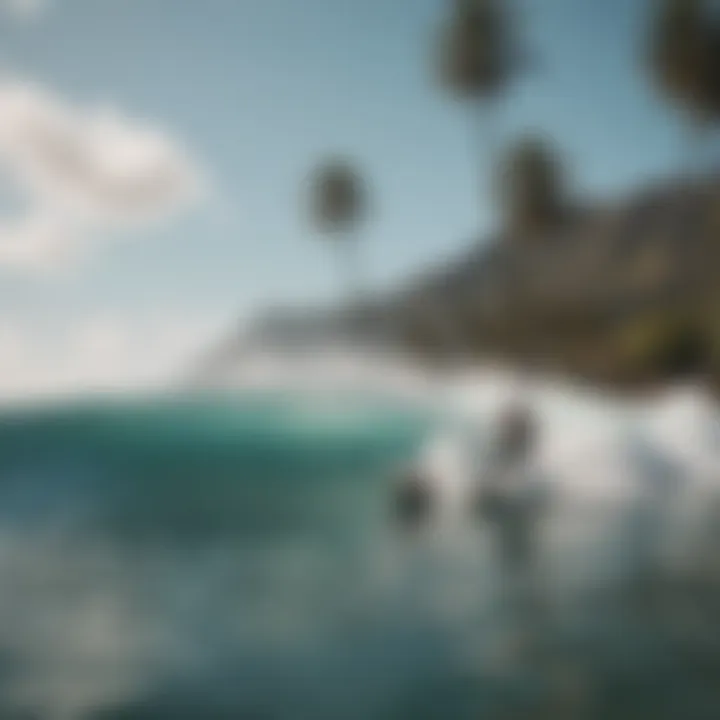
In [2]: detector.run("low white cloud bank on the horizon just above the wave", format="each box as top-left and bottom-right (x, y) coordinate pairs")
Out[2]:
(0, 314), (227, 401)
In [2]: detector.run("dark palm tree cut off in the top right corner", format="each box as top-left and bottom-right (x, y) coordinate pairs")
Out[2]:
(650, 0), (720, 173)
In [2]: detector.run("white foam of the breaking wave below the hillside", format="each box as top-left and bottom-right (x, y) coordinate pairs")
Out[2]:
(226, 346), (720, 520)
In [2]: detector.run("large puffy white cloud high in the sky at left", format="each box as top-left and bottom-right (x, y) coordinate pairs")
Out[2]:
(0, 80), (202, 270)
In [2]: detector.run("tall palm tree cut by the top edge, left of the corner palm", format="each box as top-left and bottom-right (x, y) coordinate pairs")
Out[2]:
(440, 0), (520, 194)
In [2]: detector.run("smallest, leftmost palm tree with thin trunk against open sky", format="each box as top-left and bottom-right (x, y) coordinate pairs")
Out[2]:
(311, 157), (367, 300)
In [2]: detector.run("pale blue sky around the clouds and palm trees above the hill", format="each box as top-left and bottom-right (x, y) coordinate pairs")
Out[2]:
(0, 0), (682, 394)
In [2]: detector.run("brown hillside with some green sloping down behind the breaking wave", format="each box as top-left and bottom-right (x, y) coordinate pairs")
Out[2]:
(197, 178), (720, 400)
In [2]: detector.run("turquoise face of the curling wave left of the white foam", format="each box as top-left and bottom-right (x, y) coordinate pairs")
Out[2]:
(0, 395), (428, 543)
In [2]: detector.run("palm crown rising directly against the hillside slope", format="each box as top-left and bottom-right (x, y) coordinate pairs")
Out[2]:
(497, 136), (565, 239)
